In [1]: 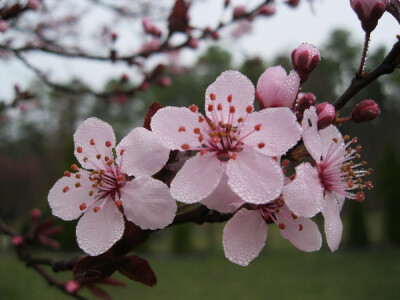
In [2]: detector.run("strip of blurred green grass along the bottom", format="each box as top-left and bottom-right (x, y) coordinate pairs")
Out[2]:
(0, 241), (400, 300)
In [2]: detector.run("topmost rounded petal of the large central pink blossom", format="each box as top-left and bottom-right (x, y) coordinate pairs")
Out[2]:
(205, 71), (254, 122)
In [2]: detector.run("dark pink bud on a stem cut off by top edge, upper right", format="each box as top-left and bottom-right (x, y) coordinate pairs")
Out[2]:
(350, 0), (390, 32)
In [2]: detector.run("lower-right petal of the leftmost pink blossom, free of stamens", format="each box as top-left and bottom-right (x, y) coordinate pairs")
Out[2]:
(121, 176), (176, 230)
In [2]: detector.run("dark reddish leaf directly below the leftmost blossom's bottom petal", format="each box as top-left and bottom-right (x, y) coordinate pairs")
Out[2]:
(72, 252), (115, 283)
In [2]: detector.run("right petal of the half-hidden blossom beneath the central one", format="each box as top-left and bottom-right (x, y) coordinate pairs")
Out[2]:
(276, 207), (322, 252)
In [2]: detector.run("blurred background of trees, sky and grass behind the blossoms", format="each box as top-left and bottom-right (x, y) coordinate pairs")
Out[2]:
(0, 0), (400, 299)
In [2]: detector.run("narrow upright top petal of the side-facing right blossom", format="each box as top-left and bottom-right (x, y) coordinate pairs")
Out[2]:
(301, 106), (322, 162)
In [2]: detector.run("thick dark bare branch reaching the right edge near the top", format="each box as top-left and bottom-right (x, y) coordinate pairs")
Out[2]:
(333, 41), (400, 109)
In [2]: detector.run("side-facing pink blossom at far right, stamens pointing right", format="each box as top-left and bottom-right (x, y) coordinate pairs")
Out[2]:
(282, 107), (372, 251)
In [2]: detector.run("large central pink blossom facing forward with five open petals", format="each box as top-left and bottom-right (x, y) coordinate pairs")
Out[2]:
(151, 71), (301, 209)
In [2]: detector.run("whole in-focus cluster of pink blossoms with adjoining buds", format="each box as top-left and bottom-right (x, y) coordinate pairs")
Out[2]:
(49, 44), (372, 266)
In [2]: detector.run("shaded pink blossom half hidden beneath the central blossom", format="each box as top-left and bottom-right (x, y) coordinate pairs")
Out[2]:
(223, 199), (322, 266)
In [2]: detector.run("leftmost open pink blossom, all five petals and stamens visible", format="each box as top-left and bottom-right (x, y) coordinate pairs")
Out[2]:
(48, 118), (176, 255)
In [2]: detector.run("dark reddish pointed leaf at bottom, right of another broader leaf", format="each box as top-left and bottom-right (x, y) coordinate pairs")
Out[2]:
(116, 255), (157, 286)
